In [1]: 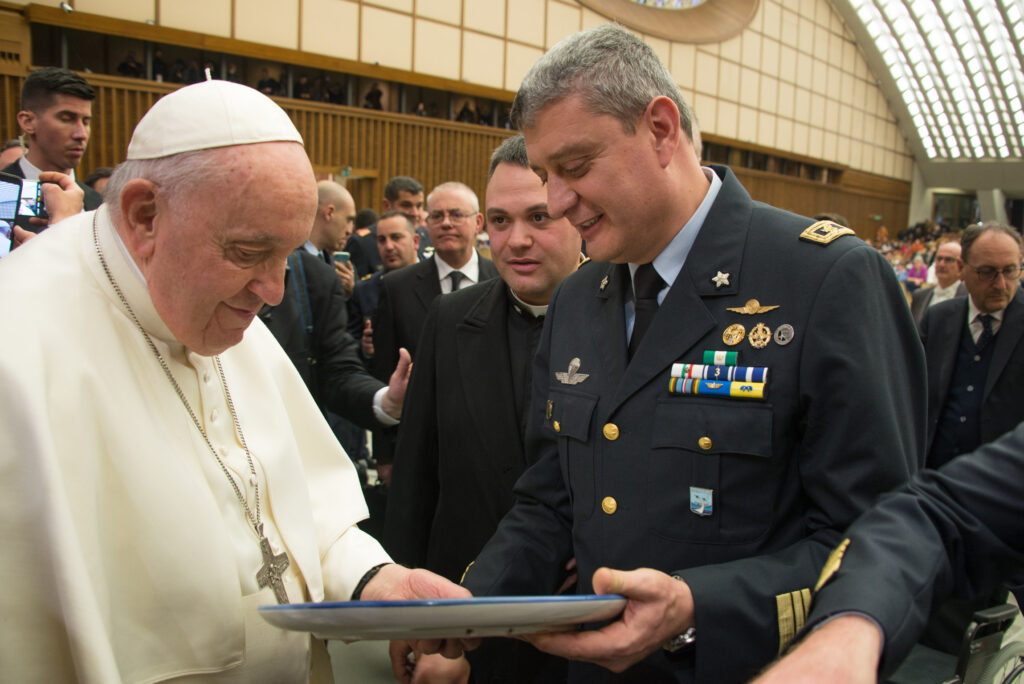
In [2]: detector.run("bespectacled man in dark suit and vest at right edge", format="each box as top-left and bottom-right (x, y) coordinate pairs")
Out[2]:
(921, 221), (1024, 653)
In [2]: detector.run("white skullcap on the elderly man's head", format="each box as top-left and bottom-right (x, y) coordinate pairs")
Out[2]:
(127, 81), (302, 160)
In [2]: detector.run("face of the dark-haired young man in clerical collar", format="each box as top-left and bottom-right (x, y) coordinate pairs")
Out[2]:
(485, 164), (581, 305)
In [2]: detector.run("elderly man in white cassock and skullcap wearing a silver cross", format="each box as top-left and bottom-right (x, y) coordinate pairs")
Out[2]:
(0, 81), (469, 684)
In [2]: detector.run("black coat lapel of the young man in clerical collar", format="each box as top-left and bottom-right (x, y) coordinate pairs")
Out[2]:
(456, 280), (523, 465)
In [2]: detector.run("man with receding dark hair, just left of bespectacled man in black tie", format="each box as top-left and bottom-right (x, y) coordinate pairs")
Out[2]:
(348, 210), (420, 348)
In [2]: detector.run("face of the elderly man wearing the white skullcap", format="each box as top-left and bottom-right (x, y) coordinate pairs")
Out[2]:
(141, 142), (316, 355)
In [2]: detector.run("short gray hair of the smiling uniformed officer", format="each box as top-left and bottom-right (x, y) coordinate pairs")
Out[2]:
(511, 24), (700, 157)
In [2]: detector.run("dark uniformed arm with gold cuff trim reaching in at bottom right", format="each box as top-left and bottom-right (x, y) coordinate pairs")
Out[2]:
(756, 424), (1024, 684)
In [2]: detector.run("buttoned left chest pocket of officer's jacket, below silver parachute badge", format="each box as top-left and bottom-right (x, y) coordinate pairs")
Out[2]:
(548, 391), (597, 519)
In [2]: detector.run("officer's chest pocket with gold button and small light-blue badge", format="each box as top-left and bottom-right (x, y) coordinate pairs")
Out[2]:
(646, 397), (778, 544)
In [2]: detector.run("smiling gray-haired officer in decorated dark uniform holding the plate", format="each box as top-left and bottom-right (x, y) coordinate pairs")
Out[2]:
(449, 25), (925, 682)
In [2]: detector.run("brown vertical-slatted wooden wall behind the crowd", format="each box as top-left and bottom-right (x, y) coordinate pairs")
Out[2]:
(0, 74), (910, 233)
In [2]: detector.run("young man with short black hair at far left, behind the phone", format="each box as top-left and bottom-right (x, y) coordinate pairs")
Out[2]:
(2, 67), (103, 232)
